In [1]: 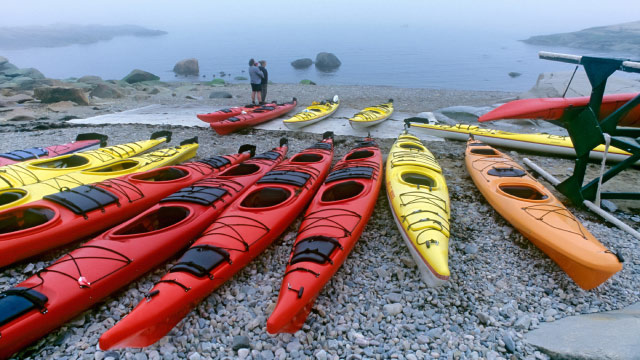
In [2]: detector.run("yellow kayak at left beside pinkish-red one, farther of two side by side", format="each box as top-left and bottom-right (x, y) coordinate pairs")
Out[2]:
(0, 131), (171, 189)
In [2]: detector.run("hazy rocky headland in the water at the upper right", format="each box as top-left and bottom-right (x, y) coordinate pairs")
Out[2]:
(522, 21), (640, 57)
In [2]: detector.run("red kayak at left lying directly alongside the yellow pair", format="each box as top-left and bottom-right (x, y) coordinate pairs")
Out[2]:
(0, 145), (255, 267)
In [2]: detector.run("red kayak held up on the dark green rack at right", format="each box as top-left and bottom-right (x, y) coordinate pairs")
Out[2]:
(478, 93), (640, 127)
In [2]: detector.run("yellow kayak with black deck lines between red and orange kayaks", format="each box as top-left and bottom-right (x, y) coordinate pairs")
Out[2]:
(385, 132), (450, 286)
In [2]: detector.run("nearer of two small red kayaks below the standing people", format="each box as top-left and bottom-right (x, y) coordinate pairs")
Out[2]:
(210, 98), (298, 135)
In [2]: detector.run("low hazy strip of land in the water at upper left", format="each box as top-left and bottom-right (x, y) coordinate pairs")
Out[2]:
(0, 24), (167, 49)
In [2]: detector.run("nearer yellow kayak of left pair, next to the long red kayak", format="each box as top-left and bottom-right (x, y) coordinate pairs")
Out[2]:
(0, 138), (198, 210)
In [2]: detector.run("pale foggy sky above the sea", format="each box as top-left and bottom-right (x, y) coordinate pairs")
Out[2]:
(0, 0), (640, 36)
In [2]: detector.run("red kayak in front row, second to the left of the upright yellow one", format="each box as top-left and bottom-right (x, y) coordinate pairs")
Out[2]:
(100, 132), (333, 350)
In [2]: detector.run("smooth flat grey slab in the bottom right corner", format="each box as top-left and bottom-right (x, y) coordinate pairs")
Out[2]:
(526, 303), (640, 359)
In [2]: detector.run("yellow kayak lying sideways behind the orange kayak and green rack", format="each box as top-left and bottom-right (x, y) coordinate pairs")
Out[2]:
(405, 118), (640, 163)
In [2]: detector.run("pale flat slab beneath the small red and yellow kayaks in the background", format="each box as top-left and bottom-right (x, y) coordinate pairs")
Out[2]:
(69, 105), (444, 141)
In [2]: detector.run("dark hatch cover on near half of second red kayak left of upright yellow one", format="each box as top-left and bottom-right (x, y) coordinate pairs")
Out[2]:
(169, 245), (231, 277)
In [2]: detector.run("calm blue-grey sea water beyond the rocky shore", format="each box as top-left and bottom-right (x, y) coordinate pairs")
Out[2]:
(0, 25), (632, 91)
